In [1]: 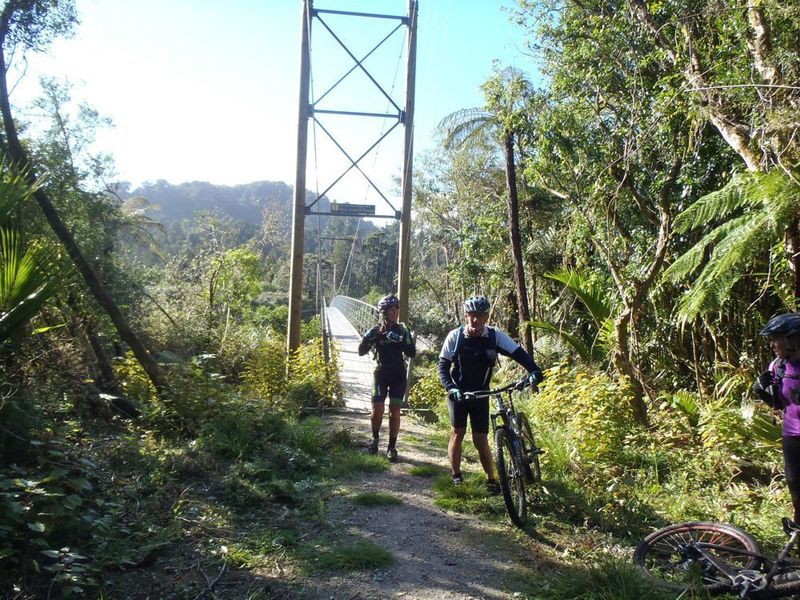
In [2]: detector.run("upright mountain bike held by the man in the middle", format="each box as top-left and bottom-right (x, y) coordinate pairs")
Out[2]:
(464, 378), (543, 528)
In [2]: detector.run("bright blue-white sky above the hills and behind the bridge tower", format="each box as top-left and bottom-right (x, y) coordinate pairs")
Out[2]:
(12, 0), (533, 211)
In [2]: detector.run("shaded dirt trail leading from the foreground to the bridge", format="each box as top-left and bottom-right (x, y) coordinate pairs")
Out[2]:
(293, 413), (552, 600)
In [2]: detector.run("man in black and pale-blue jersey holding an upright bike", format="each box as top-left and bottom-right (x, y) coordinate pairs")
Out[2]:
(438, 296), (544, 495)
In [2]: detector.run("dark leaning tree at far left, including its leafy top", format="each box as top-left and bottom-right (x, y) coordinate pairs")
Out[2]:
(0, 0), (164, 390)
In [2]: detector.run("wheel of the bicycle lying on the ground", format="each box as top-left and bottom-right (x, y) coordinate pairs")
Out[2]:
(633, 522), (761, 594)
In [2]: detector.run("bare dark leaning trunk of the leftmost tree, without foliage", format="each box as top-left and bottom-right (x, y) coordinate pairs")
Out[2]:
(0, 23), (164, 391)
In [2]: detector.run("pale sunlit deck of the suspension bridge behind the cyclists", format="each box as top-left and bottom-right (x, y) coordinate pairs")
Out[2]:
(327, 308), (375, 412)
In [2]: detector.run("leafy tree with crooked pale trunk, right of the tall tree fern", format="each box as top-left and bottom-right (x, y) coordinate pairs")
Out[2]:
(519, 0), (724, 422)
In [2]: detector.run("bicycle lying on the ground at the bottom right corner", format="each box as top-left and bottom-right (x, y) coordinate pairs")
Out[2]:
(633, 518), (800, 599)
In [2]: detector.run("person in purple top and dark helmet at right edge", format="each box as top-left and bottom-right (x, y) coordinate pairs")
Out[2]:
(753, 313), (800, 523)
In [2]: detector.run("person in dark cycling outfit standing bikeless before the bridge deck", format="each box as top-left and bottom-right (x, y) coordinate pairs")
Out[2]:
(358, 295), (417, 462)
